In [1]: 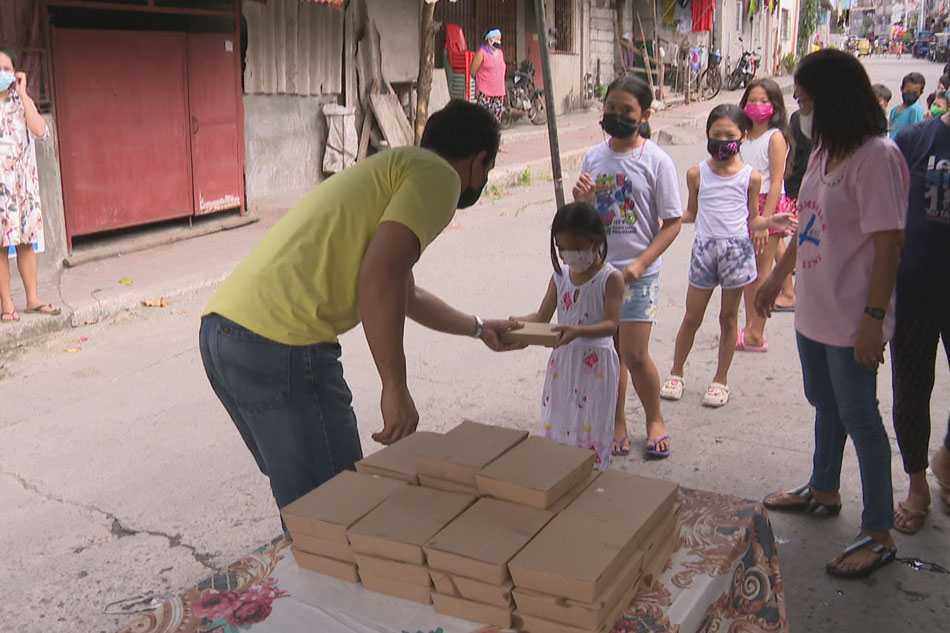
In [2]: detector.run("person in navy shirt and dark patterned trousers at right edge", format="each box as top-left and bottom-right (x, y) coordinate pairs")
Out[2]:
(891, 100), (950, 534)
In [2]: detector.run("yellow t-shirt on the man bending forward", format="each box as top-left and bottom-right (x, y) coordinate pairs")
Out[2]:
(202, 147), (460, 345)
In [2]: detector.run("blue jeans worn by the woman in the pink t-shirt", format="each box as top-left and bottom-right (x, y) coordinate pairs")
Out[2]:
(797, 334), (894, 532)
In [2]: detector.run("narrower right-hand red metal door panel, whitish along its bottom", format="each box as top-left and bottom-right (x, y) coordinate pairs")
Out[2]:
(188, 33), (244, 214)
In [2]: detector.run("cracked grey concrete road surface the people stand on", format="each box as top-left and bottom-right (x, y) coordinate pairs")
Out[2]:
(0, 67), (950, 633)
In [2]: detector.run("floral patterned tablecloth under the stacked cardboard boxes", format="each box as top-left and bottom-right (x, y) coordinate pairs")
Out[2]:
(118, 489), (788, 633)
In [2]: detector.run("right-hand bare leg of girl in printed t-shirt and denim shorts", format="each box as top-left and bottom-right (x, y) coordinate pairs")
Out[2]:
(620, 322), (670, 451)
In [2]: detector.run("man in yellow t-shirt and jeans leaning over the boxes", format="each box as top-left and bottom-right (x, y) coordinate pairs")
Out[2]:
(200, 101), (513, 507)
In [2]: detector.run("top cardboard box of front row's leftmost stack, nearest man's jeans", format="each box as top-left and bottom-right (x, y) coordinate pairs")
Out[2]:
(281, 470), (407, 544)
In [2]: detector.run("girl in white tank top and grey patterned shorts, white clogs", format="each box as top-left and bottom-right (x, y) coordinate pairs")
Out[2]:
(660, 105), (791, 407)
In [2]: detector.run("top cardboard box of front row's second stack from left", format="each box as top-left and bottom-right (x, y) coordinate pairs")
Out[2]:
(347, 480), (476, 565)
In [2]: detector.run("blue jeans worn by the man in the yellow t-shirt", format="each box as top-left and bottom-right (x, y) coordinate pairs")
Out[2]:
(199, 314), (363, 508)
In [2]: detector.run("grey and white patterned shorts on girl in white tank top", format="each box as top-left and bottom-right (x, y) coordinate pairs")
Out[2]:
(689, 237), (758, 290)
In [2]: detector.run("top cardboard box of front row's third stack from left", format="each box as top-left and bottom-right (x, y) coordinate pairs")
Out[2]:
(423, 499), (554, 585)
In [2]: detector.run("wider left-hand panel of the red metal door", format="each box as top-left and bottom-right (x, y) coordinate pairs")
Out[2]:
(52, 29), (194, 241)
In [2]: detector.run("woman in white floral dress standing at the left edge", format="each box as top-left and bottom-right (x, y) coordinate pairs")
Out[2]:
(0, 49), (59, 323)
